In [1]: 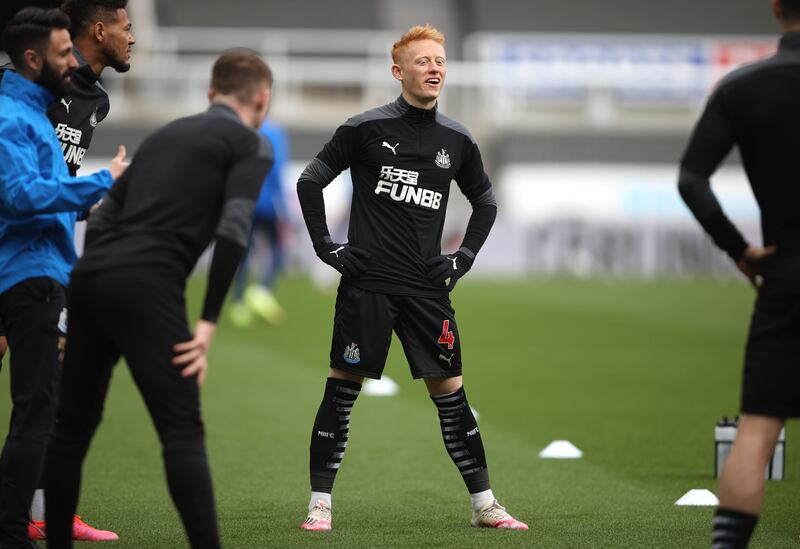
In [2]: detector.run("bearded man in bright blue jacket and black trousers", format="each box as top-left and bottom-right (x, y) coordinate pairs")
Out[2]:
(0, 8), (125, 547)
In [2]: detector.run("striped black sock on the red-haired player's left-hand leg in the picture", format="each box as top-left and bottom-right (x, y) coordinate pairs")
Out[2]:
(309, 378), (361, 494)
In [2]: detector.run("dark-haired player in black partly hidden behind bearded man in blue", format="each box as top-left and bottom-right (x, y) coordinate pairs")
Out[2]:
(0, 0), (135, 541)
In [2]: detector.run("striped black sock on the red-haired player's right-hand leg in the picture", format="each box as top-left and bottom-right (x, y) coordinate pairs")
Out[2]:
(431, 387), (490, 494)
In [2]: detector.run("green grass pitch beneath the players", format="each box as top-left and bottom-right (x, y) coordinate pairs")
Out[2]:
(0, 278), (800, 548)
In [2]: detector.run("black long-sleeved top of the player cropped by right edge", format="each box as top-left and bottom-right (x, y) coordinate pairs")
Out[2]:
(680, 32), (800, 282)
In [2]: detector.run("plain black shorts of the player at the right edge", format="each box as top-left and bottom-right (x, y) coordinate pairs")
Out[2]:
(742, 281), (800, 418)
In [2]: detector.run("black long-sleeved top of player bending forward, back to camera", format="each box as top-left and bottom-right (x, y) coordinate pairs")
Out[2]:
(73, 104), (273, 322)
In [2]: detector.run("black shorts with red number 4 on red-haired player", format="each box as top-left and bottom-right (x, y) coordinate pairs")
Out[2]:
(331, 283), (461, 379)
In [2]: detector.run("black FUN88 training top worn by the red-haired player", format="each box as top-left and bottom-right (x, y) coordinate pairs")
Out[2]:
(298, 96), (497, 297)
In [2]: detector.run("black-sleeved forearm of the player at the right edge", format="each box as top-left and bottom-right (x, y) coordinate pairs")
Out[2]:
(678, 168), (747, 261)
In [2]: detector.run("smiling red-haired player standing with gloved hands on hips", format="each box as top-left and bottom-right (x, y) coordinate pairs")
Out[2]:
(297, 25), (528, 530)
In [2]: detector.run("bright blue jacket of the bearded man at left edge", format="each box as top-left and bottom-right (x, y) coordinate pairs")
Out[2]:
(0, 71), (113, 293)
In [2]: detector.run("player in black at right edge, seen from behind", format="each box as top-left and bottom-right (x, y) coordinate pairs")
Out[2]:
(678, 0), (800, 549)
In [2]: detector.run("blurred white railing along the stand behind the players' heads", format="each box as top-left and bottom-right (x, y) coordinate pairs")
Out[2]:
(98, 27), (775, 134)
